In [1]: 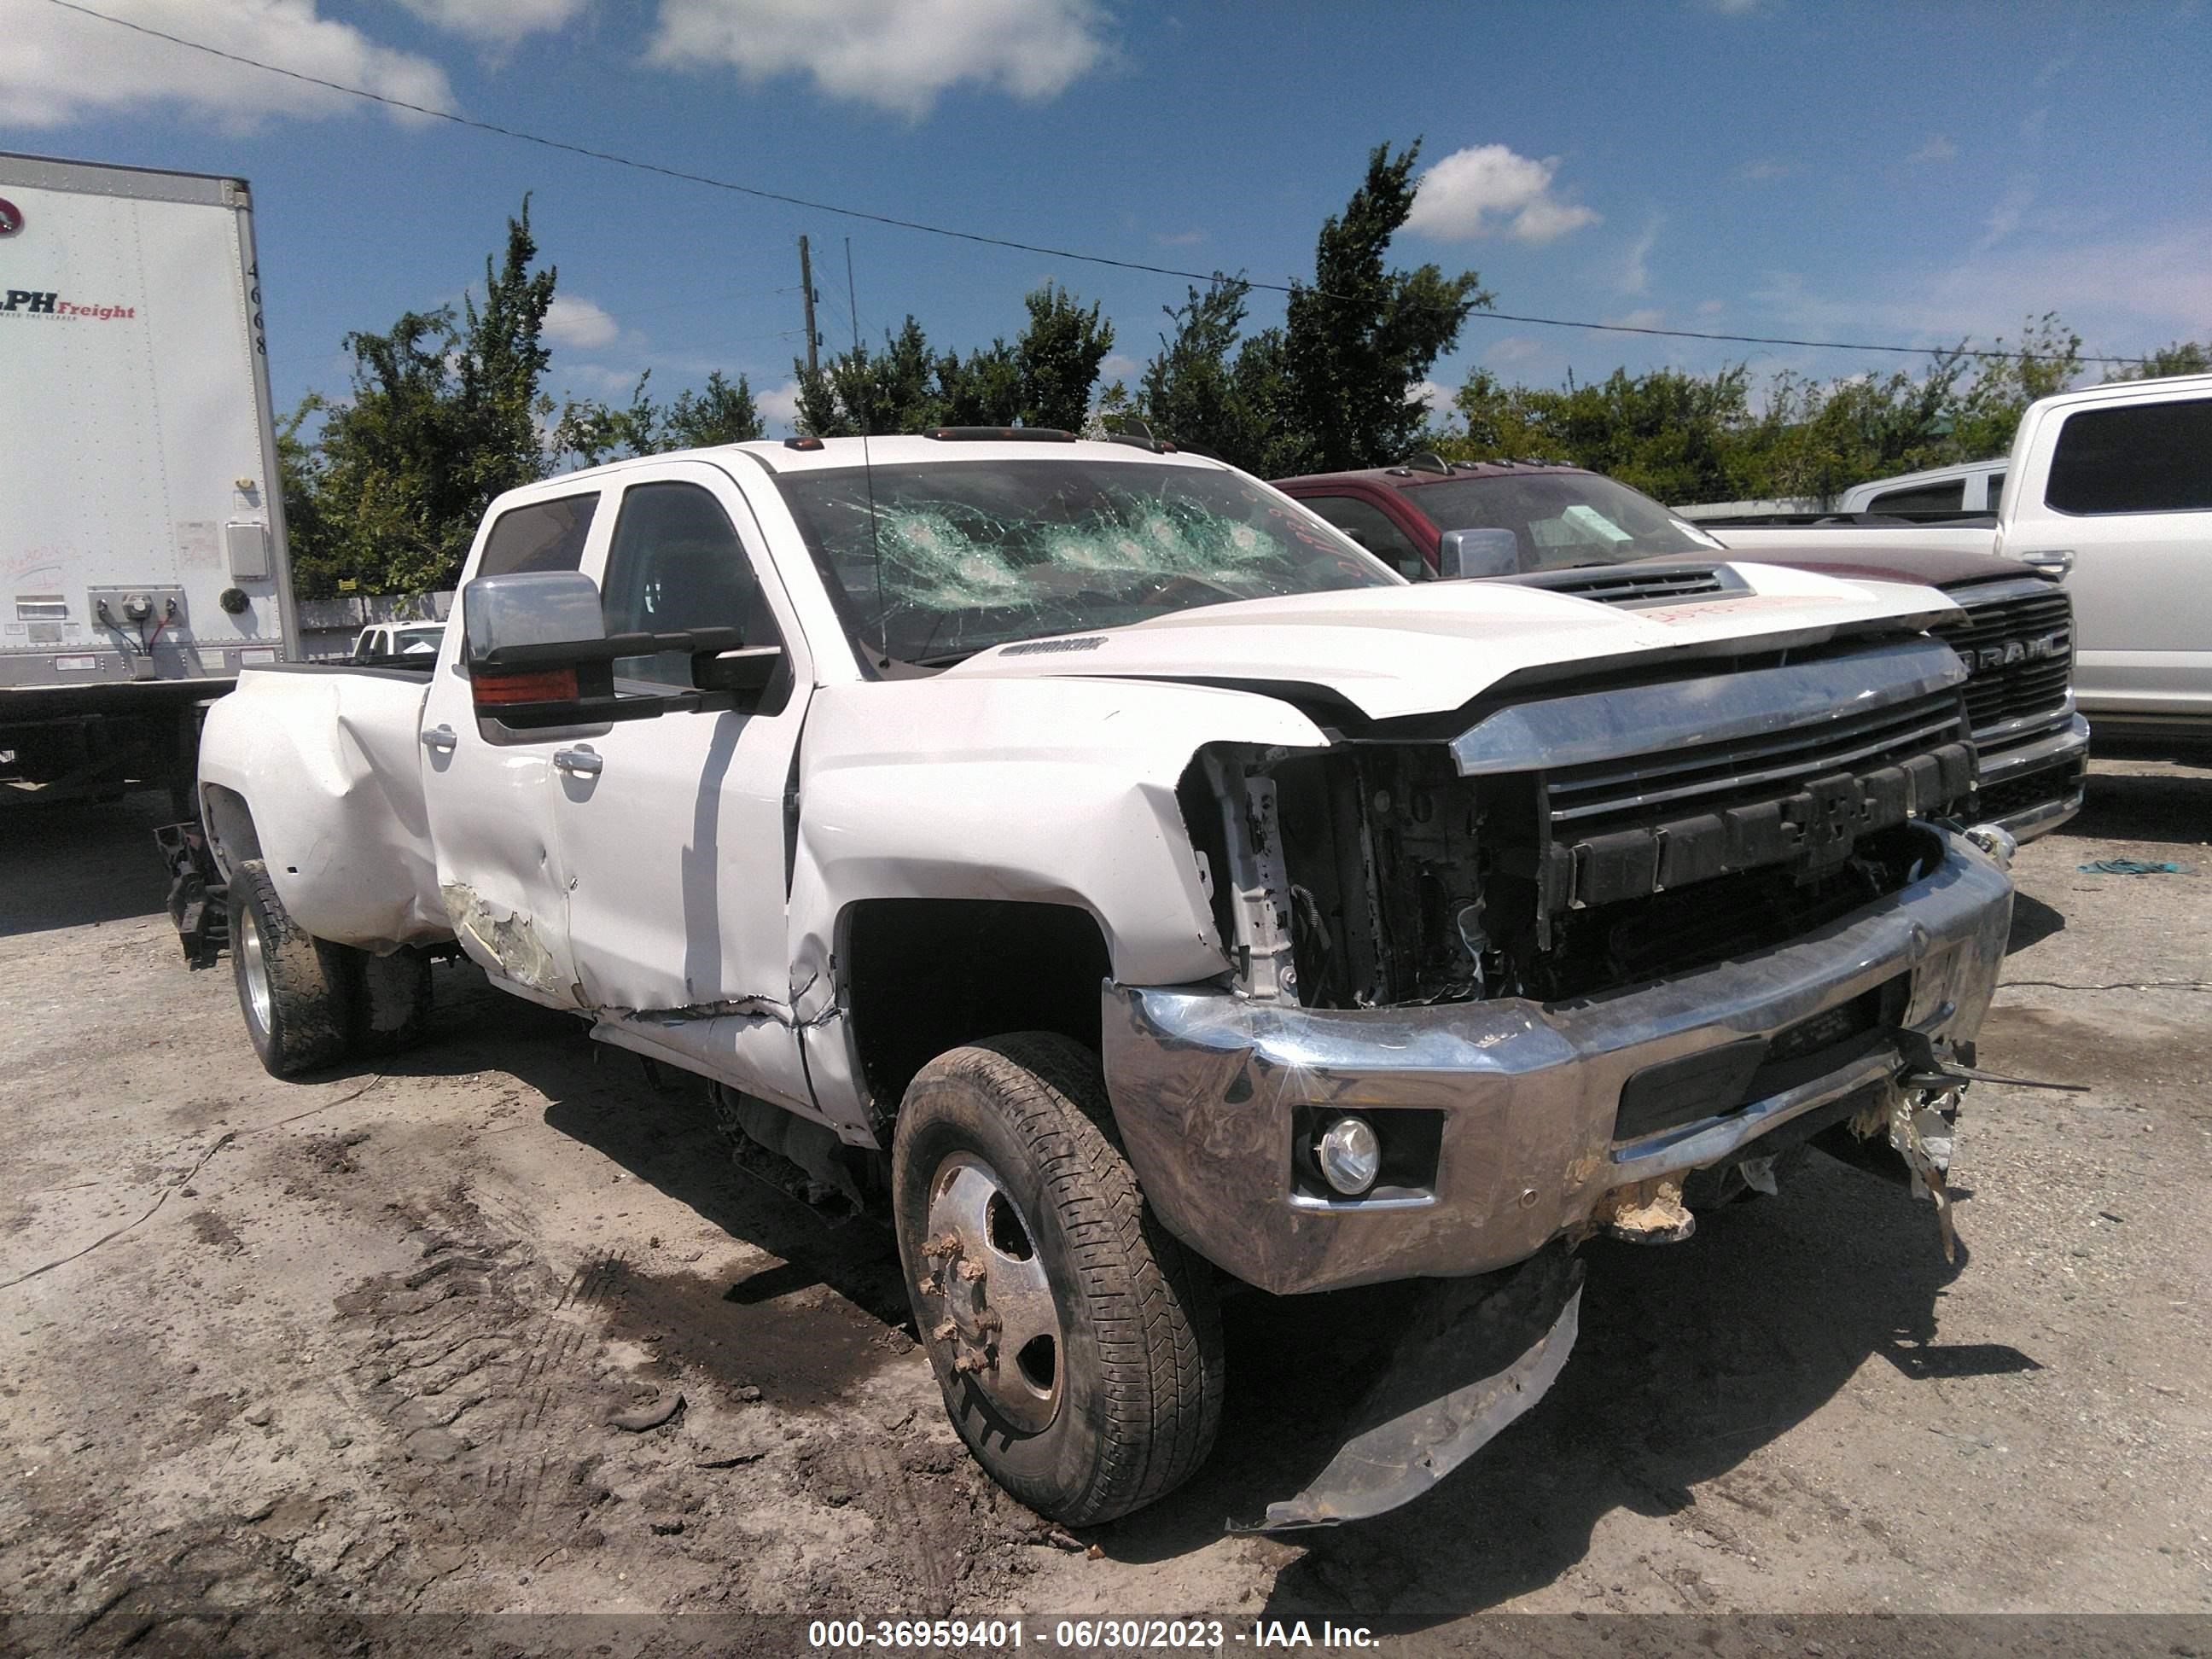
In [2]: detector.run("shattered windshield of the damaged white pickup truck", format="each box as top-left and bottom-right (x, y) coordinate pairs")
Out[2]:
(777, 458), (1398, 666)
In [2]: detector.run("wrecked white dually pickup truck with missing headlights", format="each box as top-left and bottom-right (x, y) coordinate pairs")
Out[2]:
(199, 429), (2011, 1526)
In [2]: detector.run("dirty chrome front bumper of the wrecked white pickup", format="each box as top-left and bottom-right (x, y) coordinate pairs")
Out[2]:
(1103, 830), (2013, 1294)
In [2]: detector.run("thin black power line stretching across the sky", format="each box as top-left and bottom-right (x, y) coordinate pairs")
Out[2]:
(46, 0), (2145, 365)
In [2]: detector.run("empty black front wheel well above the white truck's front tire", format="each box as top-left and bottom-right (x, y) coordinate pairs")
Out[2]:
(845, 898), (1110, 1144)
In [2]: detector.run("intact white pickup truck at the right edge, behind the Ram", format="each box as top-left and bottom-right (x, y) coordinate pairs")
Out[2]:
(1703, 374), (2212, 739)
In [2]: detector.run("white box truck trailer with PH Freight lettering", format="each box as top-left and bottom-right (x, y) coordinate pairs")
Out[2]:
(0, 153), (299, 810)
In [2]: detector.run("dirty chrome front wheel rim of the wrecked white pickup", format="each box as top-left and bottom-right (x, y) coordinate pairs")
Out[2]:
(923, 1152), (1066, 1434)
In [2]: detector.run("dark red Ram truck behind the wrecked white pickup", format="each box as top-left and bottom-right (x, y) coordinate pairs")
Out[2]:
(1274, 456), (2088, 841)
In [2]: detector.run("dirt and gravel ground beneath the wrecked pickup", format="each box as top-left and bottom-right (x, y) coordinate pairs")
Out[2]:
(0, 759), (2212, 1652)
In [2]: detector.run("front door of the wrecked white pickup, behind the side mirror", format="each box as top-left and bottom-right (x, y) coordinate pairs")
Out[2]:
(553, 460), (814, 1110)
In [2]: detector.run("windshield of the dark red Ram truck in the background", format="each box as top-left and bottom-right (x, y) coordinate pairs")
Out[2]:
(1409, 471), (1719, 571)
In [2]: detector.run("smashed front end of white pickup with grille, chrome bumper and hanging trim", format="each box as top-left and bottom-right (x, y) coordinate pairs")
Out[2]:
(1103, 639), (2011, 1524)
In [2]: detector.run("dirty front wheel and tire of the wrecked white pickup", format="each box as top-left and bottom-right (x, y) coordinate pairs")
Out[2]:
(892, 1033), (1223, 1526)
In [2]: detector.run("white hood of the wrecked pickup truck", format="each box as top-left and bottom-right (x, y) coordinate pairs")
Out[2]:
(945, 564), (1958, 719)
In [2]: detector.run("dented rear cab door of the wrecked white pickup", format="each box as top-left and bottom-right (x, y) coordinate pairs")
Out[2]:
(422, 489), (604, 1009)
